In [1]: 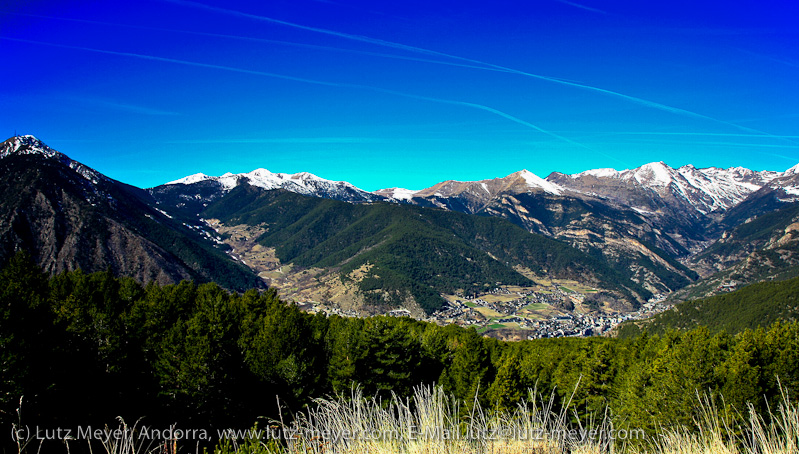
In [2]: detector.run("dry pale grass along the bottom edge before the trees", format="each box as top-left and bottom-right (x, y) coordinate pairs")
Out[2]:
(20, 387), (799, 454)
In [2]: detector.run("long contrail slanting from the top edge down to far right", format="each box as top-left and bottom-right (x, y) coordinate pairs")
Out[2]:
(164, 0), (792, 144)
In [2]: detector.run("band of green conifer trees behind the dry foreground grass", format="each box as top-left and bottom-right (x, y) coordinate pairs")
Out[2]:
(0, 255), (799, 448)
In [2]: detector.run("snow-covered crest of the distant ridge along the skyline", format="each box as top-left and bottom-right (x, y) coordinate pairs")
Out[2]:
(158, 156), (799, 215)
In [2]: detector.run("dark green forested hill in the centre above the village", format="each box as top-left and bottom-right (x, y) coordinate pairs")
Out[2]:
(202, 185), (648, 311)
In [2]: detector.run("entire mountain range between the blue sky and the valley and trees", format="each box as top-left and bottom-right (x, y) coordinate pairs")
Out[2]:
(0, 136), (799, 313)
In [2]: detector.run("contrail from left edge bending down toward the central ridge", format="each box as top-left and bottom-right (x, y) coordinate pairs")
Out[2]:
(0, 36), (593, 151)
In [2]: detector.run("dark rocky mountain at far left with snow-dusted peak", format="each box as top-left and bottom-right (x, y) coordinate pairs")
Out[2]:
(0, 136), (260, 288)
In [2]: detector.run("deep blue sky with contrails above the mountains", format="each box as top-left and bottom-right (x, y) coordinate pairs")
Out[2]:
(0, 0), (799, 190)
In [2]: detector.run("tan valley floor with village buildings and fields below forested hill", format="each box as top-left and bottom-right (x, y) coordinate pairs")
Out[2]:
(211, 219), (666, 339)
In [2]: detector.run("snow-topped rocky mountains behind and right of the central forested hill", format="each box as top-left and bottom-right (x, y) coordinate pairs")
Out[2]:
(368, 162), (799, 293)
